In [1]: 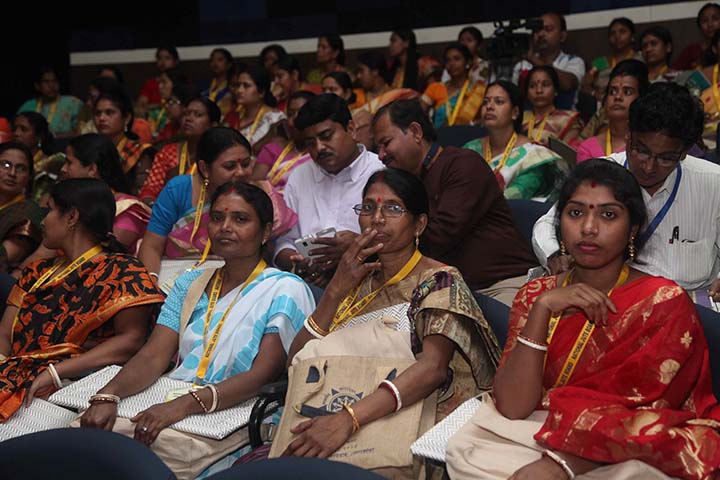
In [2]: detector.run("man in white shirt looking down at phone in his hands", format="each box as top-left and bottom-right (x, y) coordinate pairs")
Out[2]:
(275, 94), (384, 286)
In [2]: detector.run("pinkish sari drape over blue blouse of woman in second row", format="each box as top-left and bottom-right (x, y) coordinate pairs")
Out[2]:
(164, 180), (297, 258)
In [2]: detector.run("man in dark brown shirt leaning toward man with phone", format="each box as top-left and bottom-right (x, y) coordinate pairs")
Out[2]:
(372, 100), (538, 304)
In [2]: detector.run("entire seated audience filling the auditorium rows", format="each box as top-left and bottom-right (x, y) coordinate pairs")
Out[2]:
(0, 3), (720, 480)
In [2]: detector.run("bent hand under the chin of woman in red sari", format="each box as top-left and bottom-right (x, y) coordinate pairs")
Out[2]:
(533, 283), (617, 326)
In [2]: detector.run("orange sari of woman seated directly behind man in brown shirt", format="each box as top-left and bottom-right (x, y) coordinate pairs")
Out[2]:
(422, 82), (487, 128)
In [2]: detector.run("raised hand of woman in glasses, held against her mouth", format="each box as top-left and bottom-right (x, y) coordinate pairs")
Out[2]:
(327, 228), (383, 298)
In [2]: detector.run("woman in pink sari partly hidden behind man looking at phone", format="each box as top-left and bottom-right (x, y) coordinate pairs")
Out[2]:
(252, 90), (315, 193)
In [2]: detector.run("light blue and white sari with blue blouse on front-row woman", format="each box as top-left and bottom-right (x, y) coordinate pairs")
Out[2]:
(158, 268), (315, 384)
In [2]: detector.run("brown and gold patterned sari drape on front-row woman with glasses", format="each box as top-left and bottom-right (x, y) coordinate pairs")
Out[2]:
(338, 266), (500, 421)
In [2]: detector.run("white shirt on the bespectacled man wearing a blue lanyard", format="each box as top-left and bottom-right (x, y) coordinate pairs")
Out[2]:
(532, 152), (720, 290)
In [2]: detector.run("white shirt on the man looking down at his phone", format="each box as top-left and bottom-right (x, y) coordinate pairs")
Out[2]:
(275, 145), (385, 255)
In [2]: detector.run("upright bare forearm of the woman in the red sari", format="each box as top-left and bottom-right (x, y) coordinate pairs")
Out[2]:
(493, 304), (550, 419)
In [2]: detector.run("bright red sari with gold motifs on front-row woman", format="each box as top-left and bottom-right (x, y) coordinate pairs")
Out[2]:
(501, 277), (720, 479)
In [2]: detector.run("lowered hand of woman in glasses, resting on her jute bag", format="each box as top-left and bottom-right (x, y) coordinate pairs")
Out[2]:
(283, 410), (353, 458)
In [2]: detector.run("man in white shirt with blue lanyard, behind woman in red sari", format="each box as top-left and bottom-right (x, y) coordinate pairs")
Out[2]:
(533, 83), (720, 305)
